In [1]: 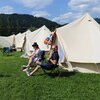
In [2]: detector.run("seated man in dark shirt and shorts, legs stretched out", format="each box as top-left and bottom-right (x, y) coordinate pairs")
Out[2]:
(27, 45), (59, 76)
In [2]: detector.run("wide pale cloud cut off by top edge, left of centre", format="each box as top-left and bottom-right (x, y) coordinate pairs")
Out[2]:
(14, 0), (53, 9)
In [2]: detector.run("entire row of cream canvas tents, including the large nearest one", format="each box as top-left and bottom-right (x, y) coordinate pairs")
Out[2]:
(0, 14), (100, 73)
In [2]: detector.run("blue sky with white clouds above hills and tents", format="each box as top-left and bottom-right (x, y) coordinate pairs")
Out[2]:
(0, 0), (100, 24)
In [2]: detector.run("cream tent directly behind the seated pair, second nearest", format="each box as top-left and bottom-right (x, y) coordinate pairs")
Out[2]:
(21, 25), (52, 57)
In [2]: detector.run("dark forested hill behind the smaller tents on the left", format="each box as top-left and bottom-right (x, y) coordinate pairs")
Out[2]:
(0, 14), (61, 36)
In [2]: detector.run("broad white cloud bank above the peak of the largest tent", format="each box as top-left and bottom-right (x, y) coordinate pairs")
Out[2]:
(53, 0), (100, 24)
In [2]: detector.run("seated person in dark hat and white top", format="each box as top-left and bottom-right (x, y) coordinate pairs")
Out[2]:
(22, 42), (40, 71)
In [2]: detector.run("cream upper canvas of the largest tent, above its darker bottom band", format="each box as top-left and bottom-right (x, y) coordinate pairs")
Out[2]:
(57, 14), (100, 63)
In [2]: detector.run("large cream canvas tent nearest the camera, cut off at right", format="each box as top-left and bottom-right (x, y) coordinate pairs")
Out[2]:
(56, 14), (100, 73)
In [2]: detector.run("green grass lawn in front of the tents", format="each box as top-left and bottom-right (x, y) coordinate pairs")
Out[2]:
(0, 52), (100, 100)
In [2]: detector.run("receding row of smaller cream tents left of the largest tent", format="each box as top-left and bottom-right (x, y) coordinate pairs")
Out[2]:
(0, 25), (52, 54)
